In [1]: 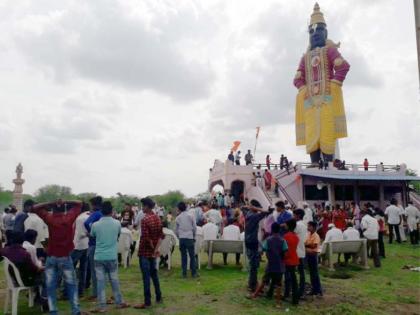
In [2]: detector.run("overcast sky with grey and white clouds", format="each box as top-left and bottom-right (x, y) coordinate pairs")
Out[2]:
(0, 0), (420, 196)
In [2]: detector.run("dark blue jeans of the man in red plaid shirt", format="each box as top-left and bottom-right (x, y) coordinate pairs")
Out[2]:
(139, 256), (162, 306)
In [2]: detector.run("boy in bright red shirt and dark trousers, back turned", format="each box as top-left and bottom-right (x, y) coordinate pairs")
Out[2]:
(283, 219), (299, 305)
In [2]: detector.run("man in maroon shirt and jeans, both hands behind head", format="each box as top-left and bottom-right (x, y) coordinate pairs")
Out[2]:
(31, 200), (85, 315)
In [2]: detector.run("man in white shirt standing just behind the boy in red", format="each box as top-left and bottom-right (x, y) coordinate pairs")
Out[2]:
(293, 209), (306, 297)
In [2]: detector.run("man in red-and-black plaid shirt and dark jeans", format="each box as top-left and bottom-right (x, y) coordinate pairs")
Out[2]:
(134, 198), (164, 309)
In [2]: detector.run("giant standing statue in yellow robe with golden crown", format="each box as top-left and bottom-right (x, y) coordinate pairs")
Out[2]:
(293, 3), (350, 163)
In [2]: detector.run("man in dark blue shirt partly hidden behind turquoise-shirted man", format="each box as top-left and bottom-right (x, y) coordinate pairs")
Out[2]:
(85, 196), (102, 300)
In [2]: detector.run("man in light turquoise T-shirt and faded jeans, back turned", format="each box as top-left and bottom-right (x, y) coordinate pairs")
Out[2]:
(90, 201), (129, 313)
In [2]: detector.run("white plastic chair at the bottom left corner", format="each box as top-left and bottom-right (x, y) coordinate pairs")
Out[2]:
(3, 257), (36, 315)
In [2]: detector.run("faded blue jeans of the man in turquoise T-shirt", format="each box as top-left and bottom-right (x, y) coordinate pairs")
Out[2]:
(95, 259), (122, 309)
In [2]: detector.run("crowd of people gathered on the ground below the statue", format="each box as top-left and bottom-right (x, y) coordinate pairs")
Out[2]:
(0, 193), (420, 314)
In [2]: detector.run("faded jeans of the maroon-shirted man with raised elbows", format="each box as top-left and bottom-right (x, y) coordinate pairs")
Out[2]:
(45, 256), (80, 315)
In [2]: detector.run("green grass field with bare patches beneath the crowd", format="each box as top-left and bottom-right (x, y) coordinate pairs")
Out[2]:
(0, 243), (420, 315)
